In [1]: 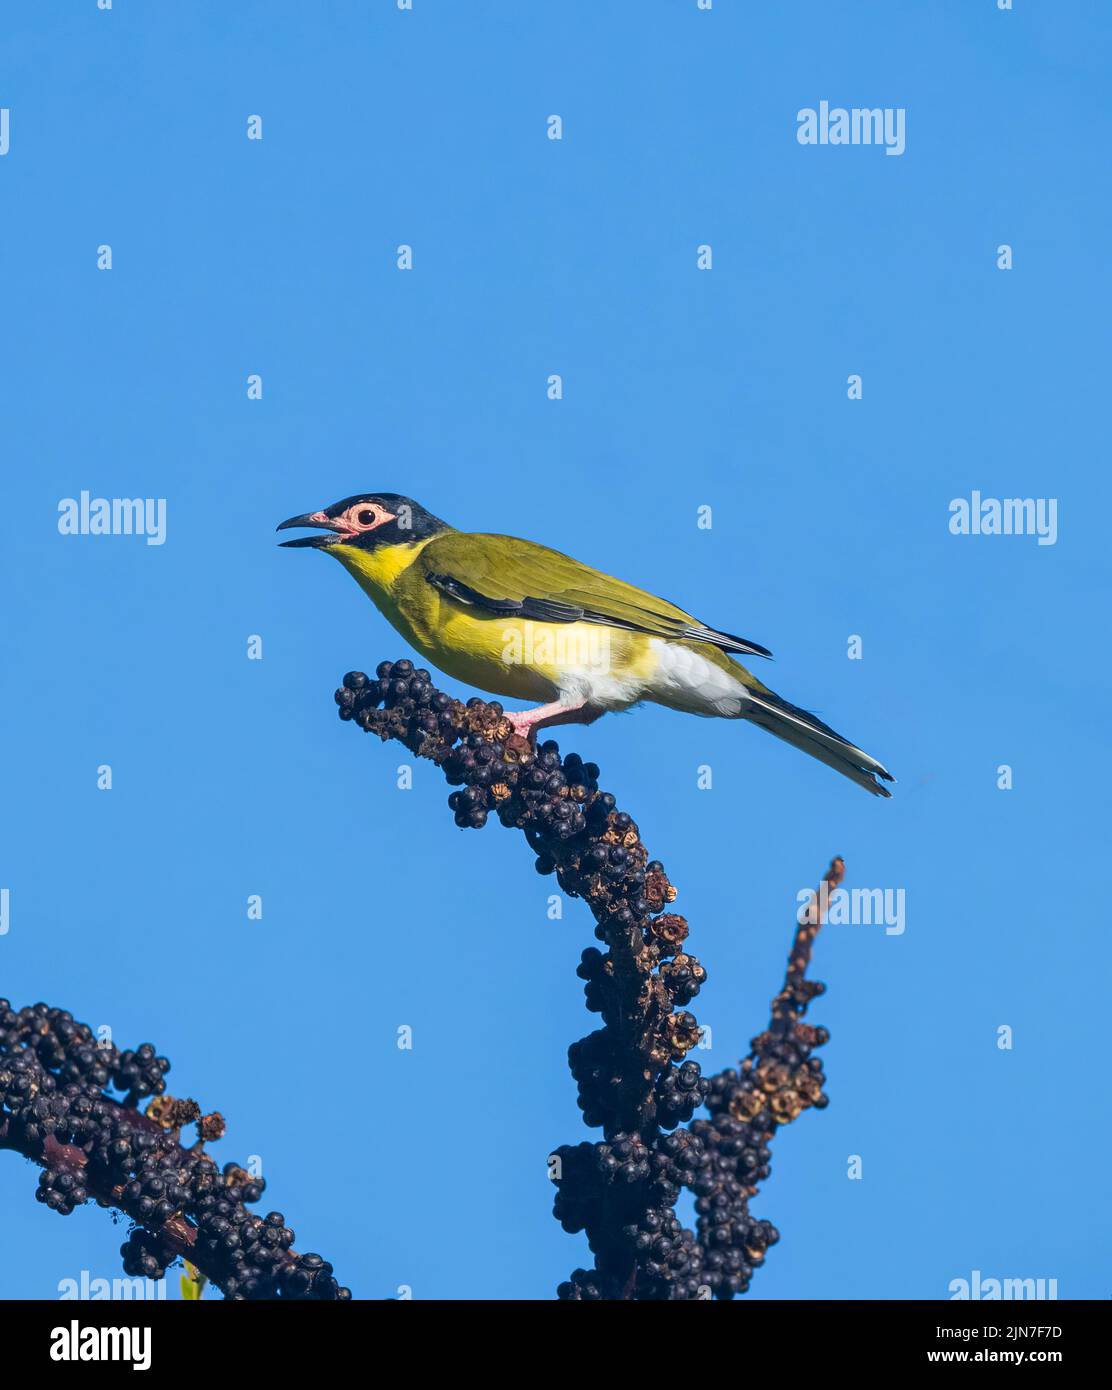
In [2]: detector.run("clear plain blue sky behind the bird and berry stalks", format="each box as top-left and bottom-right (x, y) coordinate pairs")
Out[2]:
(0, 0), (1112, 1298)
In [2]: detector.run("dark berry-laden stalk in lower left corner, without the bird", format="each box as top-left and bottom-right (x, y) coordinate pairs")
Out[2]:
(0, 999), (352, 1300)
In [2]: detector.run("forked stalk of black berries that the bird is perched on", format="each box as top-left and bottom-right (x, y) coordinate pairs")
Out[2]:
(335, 660), (826, 1300)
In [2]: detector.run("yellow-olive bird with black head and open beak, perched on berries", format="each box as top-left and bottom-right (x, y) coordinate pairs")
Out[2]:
(277, 492), (895, 796)
